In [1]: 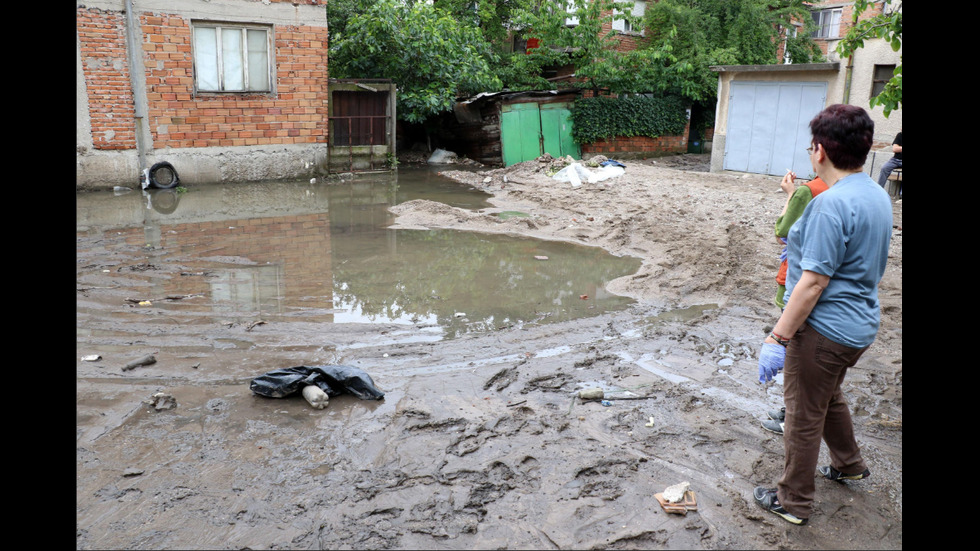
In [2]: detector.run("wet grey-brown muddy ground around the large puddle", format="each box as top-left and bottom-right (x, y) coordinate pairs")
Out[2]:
(76, 155), (902, 549)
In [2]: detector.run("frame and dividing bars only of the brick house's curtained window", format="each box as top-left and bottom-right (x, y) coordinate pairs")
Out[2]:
(191, 20), (276, 95)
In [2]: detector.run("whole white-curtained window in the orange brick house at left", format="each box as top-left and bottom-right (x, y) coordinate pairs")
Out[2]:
(194, 22), (272, 92)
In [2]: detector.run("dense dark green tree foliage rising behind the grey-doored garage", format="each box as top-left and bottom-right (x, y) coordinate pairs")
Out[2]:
(643, 0), (822, 103)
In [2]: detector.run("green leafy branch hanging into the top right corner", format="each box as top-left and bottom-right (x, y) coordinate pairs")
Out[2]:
(837, 0), (902, 117)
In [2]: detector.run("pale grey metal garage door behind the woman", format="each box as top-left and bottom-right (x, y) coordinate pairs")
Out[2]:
(723, 81), (827, 178)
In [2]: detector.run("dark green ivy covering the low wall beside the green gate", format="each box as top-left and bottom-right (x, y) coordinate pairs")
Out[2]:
(572, 96), (690, 144)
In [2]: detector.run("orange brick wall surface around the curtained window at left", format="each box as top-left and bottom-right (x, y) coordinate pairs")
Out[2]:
(76, 4), (328, 149)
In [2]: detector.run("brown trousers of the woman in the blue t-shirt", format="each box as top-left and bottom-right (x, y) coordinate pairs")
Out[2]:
(777, 323), (867, 518)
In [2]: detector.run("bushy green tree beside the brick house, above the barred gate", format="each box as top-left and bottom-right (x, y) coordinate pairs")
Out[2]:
(330, 0), (501, 122)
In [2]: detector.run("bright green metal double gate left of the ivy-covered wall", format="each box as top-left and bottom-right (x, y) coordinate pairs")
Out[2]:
(500, 102), (582, 166)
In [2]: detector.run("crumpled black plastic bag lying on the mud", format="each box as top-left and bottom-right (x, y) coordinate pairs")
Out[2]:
(249, 365), (385, 400)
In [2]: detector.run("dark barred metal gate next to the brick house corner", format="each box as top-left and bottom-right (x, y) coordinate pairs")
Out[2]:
(327, 79), (395, 173)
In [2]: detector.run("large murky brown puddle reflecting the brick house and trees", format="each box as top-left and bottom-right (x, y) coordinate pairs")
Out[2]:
(76, 168), (640, 338)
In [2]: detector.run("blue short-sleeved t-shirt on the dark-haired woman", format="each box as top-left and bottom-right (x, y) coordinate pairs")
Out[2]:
(785, 172), (892, 348)
